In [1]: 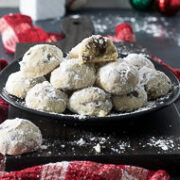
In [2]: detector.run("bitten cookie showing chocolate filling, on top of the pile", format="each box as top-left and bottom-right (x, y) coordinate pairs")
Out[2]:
(69, 35), (118, 63)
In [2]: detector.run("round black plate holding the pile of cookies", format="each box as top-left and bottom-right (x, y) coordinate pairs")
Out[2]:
(0, 60), (180, 122)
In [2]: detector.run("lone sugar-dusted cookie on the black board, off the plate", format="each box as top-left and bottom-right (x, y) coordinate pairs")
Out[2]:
(0, 118), (42, 155)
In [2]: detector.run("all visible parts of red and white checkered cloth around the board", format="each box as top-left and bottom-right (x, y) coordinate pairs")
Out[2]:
(0, 14), (180, 180)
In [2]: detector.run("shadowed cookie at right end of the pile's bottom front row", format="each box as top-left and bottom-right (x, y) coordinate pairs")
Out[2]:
(112, 85), (147, 112)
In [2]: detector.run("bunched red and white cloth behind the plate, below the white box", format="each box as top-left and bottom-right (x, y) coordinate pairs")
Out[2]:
(0, 14), (63, 53)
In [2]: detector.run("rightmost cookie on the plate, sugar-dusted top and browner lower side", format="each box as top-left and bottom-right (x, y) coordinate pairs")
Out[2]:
(139, 67), (172, 100)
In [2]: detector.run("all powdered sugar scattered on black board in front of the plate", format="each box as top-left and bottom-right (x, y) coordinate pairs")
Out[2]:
(34, 135), (180, 157)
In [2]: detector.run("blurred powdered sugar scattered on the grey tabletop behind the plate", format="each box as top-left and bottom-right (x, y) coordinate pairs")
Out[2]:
(90, 14), (169, 37)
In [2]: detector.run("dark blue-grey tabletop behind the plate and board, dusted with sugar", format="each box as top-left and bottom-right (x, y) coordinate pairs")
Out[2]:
(0, 8), (180, 180)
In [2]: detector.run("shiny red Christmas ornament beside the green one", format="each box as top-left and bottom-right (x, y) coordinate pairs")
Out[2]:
(155, 0), (180, 16)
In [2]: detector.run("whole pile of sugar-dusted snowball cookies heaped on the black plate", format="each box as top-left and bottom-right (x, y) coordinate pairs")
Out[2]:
(5, 35), (172, 116)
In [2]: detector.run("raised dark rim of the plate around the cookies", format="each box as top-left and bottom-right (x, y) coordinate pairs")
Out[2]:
(0, 59), (180, 122)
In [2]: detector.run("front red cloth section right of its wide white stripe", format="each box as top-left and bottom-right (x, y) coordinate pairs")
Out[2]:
(65, 161), (170, 180)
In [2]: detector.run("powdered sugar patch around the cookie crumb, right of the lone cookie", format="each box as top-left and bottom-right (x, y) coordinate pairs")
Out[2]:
(39, 136), (134, 155)
